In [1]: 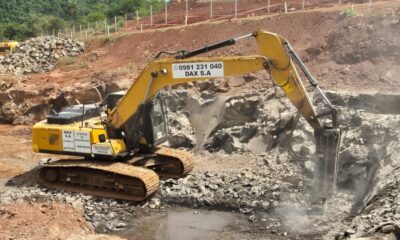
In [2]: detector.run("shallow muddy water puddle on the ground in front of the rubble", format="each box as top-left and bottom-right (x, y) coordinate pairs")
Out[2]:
(113, 209), (243, 240)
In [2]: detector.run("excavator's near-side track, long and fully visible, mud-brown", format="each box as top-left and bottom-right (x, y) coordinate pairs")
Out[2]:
(39, 160), (159, 201)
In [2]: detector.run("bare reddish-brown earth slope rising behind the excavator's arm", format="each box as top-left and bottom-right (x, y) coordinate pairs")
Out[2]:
(18, 2), (400, 95)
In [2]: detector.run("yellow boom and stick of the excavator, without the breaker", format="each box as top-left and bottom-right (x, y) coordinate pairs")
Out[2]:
(109, 31), (324, 129)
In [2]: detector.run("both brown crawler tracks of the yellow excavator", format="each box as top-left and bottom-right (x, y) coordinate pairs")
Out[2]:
(39, 147), (194, 201)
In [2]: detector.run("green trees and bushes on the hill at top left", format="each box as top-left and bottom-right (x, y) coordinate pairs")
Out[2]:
(0, 0), (164, 40)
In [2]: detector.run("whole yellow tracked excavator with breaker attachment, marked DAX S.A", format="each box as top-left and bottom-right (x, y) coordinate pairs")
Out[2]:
(32, 30), (341, 201)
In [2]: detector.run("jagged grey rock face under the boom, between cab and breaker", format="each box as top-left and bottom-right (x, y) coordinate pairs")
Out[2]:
(163, 89), (304, 154)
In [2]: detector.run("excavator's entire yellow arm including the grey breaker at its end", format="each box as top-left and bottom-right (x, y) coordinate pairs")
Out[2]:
(107, 31), (341, 198)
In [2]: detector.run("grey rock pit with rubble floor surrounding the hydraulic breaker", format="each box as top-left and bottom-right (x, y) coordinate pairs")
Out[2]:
(0, 87), (400, 239)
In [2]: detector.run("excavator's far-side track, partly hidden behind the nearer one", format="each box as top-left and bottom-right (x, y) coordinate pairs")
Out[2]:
(130, 147), (194, 178)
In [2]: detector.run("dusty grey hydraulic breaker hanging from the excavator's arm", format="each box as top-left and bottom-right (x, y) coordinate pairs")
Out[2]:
(314, 128), (341, 199)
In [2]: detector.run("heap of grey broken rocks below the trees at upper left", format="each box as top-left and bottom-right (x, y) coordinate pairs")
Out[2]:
(0, 37), (85, 74)
